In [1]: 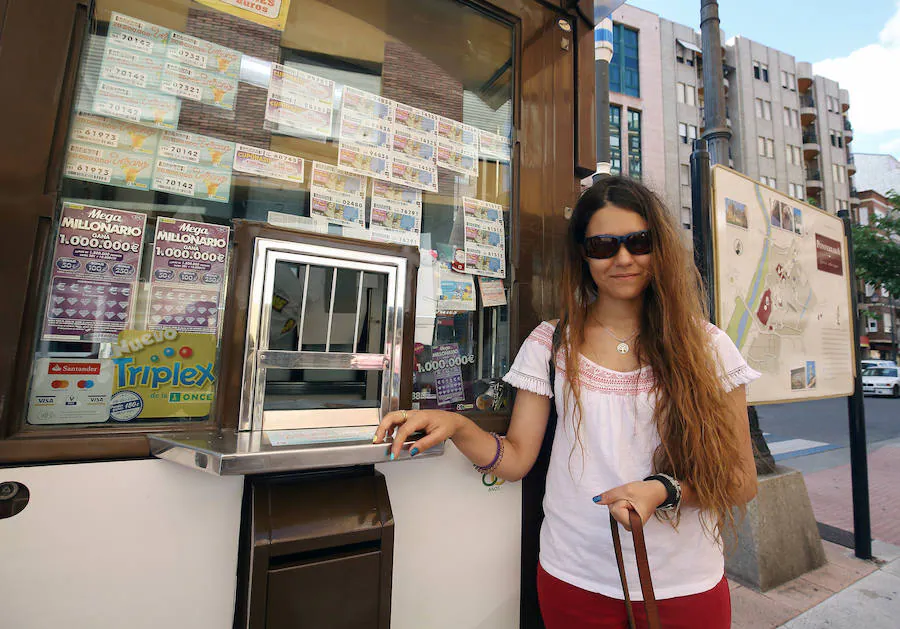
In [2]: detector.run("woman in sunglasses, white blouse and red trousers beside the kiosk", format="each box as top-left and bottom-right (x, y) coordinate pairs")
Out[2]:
(375, 177), (759, 629)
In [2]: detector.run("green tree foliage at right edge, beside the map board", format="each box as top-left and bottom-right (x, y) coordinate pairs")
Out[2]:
(853, 190), (900, 297)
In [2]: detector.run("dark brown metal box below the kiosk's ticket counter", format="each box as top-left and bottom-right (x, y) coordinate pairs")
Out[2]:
(234, 468), (394, 629)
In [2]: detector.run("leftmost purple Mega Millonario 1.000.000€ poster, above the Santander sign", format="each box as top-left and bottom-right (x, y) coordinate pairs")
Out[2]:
(41, 203), (147, 343)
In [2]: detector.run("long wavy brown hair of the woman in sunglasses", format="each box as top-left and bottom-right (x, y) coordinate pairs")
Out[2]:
(560, 176), (741, 531)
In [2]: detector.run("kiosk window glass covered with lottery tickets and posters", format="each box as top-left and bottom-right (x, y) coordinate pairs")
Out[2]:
(24, 0), (514, 431)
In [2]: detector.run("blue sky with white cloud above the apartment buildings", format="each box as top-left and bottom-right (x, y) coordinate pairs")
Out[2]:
(628, 0), (900, 159)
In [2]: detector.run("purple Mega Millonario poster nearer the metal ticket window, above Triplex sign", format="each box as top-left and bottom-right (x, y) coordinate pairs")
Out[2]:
(147, 217), (228, 334)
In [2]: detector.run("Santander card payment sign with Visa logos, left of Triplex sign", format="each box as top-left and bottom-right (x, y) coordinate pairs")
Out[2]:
(28, 358), (113, 426)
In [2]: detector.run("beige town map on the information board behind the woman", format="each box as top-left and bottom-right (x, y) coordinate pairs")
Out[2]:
(712, 166), (854, 404)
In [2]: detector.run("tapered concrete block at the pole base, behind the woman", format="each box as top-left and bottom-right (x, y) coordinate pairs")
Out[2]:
(725, 465), (826, 591)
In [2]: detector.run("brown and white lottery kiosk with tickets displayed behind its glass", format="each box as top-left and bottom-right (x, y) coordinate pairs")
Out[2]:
(0, 0), (595, 629)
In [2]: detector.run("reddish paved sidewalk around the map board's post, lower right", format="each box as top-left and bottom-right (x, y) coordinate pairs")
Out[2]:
(731, 445), (900, 629)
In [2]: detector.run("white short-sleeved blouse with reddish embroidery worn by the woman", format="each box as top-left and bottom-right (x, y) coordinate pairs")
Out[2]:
(503, 322), (760, 601)
